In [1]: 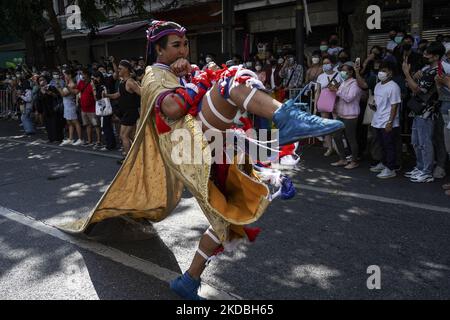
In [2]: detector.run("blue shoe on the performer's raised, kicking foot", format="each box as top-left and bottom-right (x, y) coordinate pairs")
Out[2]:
(273, 100), (345, 146)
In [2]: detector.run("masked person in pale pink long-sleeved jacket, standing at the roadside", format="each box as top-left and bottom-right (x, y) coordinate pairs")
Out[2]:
(330, 62), (362, 170)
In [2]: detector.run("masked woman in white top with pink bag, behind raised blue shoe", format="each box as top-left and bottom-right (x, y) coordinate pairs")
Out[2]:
(316, 56), (342, 157)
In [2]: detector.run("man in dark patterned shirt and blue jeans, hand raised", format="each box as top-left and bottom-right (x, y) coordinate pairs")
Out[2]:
(402, 42), (445, 183)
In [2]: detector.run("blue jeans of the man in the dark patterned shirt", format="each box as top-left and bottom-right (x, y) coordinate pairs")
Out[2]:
(411, 117), (434, 175)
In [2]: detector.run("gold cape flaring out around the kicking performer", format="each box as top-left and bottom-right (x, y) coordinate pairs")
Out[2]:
(59, 67), (269, 242)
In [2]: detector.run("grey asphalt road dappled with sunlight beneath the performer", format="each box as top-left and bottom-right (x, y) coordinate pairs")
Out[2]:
(0, 120), (450, 300)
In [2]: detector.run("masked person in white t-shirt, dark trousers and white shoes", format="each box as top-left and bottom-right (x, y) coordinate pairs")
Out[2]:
(370, 62), (402, 179)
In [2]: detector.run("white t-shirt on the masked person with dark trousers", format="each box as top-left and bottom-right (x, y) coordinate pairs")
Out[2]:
(372, 80), (402, 129)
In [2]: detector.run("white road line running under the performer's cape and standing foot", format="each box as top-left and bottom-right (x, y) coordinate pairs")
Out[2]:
(0, 206), (242, 300)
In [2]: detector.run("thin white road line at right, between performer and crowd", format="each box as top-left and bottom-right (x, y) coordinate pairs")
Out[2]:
(299, 185), (450, 213)
